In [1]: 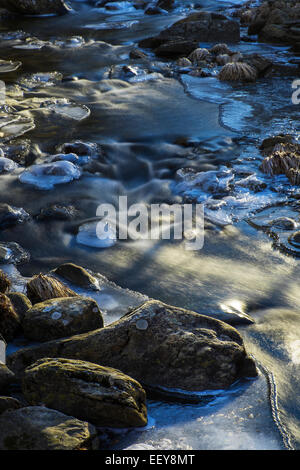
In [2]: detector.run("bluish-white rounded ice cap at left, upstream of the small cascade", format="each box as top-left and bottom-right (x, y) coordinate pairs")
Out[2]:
(20, 161), (81, 189)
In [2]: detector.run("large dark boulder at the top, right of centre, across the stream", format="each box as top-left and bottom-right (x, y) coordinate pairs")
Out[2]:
(139, 11), (240, 57)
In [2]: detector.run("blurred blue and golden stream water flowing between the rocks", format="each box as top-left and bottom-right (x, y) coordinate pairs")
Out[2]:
(0, 0), (300, 449)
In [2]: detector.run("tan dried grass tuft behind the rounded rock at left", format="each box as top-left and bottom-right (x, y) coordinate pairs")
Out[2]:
(27, 274), (77, 304)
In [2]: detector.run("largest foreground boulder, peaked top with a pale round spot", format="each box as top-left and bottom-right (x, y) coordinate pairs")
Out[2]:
(8, 300), (256, 390)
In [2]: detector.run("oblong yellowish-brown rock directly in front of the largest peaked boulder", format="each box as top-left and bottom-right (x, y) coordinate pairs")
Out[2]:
(23, 359), (147, 428)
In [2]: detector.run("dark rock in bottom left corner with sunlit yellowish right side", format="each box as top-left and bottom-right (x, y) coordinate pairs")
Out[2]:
(0, 406), (96, 450)
